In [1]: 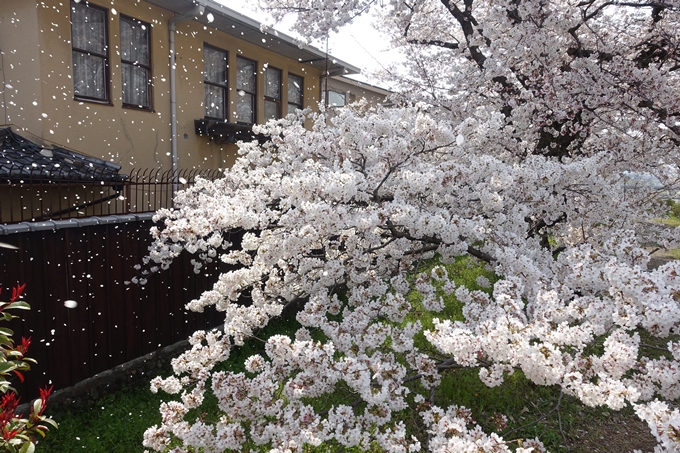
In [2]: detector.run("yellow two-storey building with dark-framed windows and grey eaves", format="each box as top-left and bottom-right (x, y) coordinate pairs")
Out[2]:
(0, 0), (359, 174)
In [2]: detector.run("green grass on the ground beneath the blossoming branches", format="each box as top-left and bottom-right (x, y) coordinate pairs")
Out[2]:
(38, 259), (664, 453)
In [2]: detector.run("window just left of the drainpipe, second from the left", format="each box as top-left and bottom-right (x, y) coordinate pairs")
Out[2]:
(120, 16), (151, 109)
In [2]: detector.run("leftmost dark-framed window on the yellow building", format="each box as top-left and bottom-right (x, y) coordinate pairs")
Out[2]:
(71, 2), (109, 102)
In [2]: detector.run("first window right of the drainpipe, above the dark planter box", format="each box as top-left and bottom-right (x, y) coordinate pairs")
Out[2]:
(203, 45), (229, 119)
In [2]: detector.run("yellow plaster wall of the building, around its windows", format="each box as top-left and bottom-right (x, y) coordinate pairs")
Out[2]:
(0, 0), (320, 173)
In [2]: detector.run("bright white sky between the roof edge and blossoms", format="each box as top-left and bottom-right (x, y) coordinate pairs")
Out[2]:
(216, 0), (399, 88)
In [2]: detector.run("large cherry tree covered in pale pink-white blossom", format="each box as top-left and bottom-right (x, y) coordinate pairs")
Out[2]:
(144, 0), (680, 452)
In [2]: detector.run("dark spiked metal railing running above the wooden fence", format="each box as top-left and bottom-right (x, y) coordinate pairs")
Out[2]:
(0, 168), (222, 224)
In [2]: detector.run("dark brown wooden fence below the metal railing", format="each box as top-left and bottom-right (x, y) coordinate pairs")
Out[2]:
(0, 221), (231, 397)
